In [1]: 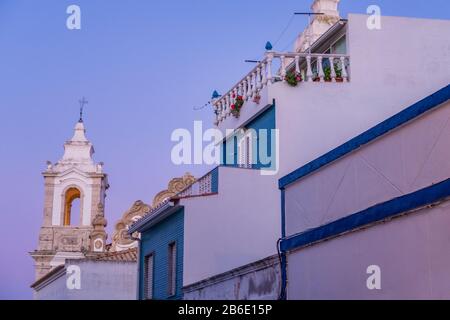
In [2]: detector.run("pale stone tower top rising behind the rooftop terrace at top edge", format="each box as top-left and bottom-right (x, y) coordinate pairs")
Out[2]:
(294, 0), (341, 52)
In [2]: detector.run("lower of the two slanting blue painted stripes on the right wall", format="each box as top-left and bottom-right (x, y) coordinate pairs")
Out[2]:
(280, 179), (450, 252)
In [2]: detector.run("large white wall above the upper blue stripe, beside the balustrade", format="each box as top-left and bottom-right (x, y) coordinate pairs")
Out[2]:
(272, 14), (450, 175)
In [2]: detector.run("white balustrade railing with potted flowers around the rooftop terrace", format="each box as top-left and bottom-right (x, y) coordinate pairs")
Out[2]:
(212, 51), (350, 125)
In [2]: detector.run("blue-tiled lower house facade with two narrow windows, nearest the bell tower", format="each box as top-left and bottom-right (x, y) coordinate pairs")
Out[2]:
(139, 208), (184, 300)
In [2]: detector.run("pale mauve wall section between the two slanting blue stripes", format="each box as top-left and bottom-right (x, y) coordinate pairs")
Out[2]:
(286, 102), (450, 236)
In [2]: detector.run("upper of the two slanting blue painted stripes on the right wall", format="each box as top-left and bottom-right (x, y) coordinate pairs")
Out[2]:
(278, 85), (450, 189)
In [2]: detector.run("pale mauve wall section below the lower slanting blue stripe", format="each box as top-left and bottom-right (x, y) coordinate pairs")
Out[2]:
(288, 202), (450, 300)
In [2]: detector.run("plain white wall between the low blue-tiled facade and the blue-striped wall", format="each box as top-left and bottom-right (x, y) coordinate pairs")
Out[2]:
(181, 168), (281, 286)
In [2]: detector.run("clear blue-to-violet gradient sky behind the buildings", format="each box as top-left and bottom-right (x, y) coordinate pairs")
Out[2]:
(0, 0), (450, 299)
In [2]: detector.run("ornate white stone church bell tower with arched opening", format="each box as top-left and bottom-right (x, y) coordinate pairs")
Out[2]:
(30, 117), (109, 280)
